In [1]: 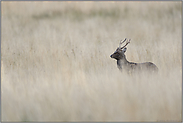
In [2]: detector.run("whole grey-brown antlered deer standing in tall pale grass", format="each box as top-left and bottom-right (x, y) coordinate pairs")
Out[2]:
(110, 38), (158, 73)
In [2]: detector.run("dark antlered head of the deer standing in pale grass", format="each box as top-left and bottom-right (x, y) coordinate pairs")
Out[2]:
(110, 38), (131, 60)
